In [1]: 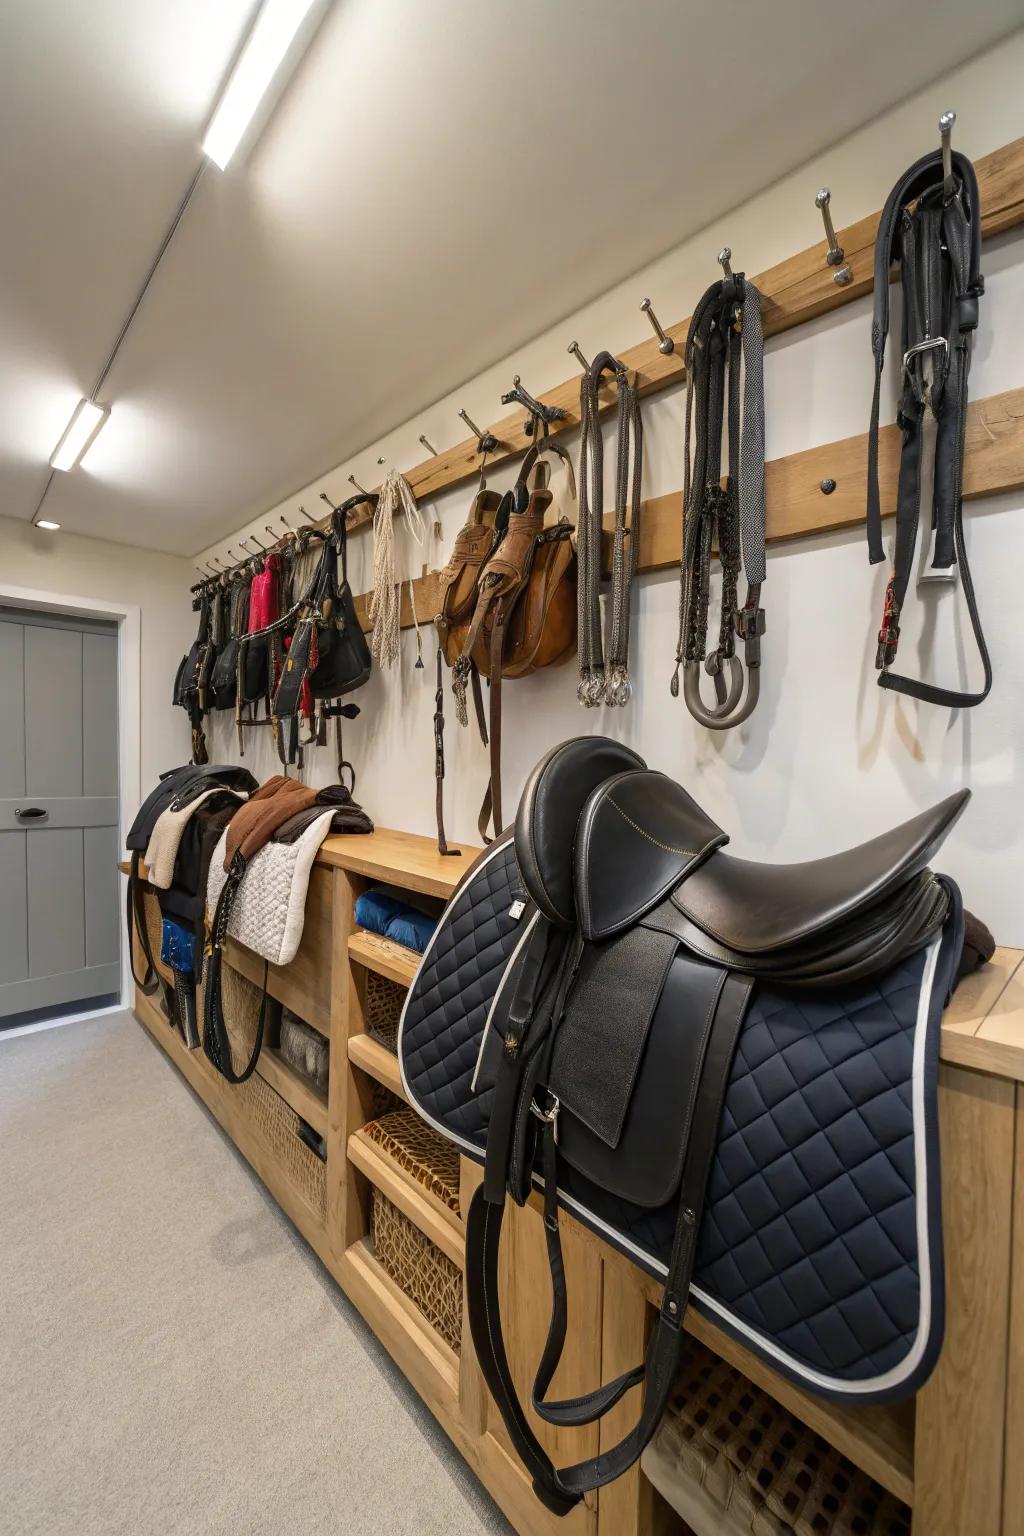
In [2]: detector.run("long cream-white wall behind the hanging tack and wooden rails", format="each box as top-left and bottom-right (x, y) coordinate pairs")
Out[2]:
(199, 32), (1024, 945)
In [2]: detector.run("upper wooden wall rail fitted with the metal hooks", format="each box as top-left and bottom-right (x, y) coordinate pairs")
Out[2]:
(333, 138), (1024, 540)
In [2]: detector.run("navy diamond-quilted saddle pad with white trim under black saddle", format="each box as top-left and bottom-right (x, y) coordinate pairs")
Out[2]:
(398, 839), (961, 1402)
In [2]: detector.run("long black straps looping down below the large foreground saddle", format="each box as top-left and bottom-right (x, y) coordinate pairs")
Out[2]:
(465, 952), (752, 1514)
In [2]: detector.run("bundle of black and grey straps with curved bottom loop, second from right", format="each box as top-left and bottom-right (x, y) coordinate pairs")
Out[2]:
(671, 247), (766, 731)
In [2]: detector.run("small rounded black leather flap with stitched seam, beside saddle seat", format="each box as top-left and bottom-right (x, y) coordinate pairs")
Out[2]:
(573, 768), (729, 940)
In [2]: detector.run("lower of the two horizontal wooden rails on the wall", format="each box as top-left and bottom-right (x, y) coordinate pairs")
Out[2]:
(356, 389), (1024, 628)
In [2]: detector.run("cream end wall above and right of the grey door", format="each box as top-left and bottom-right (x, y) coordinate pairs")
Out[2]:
(0, 518), (197, 816)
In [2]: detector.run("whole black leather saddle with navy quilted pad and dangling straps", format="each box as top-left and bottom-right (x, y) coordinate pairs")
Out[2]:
(398, 737), (992, 1513)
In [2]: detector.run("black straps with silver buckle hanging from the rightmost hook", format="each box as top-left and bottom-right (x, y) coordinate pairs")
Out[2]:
(867, 151), (992, 708)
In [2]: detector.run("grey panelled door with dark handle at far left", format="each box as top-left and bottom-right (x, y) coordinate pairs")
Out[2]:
(0, 610), (121, 1028)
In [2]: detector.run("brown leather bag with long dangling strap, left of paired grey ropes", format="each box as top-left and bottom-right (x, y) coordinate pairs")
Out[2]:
(453, 439), (577, 842)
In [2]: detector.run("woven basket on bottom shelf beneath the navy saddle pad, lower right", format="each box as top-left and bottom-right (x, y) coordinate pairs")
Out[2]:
(649, 1339), (910, 1536)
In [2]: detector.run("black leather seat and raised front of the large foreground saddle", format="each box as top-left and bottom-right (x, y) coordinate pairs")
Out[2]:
(516, 737), (969, 982)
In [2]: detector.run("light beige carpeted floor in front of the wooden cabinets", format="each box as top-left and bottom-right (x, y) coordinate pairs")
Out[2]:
(0, 1014), (508, 1536)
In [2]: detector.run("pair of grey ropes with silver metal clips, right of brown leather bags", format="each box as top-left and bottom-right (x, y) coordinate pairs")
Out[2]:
(576, 352), (643, 708)
